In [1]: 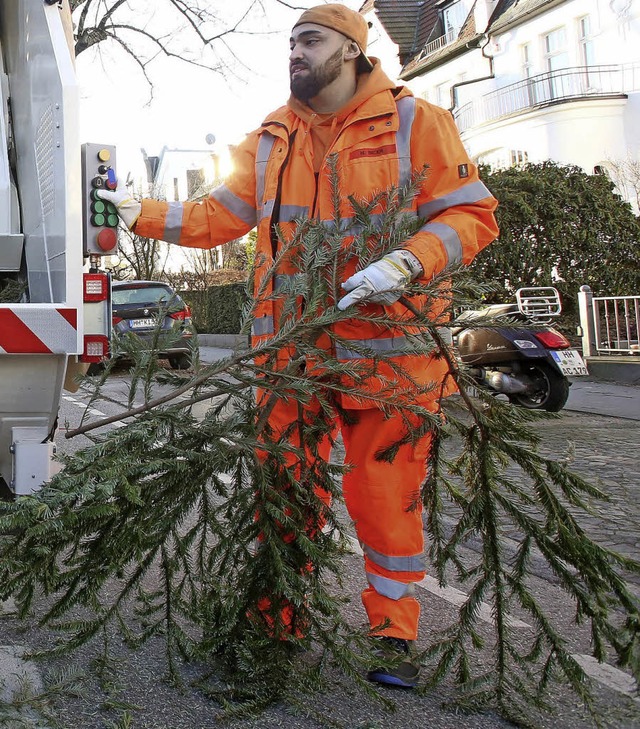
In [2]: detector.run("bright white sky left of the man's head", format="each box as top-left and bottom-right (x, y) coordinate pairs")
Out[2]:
(77, 0), (380, 178)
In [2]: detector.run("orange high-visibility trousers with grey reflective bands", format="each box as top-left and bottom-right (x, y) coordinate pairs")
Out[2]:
(260, 398), (439, 640)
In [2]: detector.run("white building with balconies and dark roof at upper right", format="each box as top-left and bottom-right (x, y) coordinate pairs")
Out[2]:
(365, 0), (640, 204)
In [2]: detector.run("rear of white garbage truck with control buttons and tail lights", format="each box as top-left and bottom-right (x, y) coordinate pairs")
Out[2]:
(0, 0), (117, 498)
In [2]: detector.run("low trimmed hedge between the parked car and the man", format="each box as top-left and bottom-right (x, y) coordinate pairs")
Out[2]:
(180, 283), (247, 334)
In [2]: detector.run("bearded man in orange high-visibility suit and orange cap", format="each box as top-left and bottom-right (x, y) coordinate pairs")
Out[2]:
(101, 4), (498, 687)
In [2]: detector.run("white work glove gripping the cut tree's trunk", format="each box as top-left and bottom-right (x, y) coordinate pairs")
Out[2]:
(338, 250), (422, 311)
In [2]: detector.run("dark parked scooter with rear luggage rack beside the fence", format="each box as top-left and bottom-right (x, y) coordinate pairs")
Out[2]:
(452, 287), (588, 412)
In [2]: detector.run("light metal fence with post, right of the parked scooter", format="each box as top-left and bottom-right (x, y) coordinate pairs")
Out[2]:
(578, 286), (640, 357)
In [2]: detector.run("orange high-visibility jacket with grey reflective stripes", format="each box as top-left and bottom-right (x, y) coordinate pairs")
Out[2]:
(135, 70), (498, 409)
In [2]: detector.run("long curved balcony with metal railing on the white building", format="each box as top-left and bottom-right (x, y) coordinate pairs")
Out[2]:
(454, 63), (640, 132)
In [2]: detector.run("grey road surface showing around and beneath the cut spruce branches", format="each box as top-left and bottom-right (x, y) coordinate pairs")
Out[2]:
(0, 358), (640, 729)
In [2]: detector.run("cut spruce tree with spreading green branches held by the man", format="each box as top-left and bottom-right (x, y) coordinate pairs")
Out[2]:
(0, 170), (640, 725)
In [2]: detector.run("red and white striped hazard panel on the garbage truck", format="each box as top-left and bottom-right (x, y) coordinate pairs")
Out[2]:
(0, 304), (78, 354)
